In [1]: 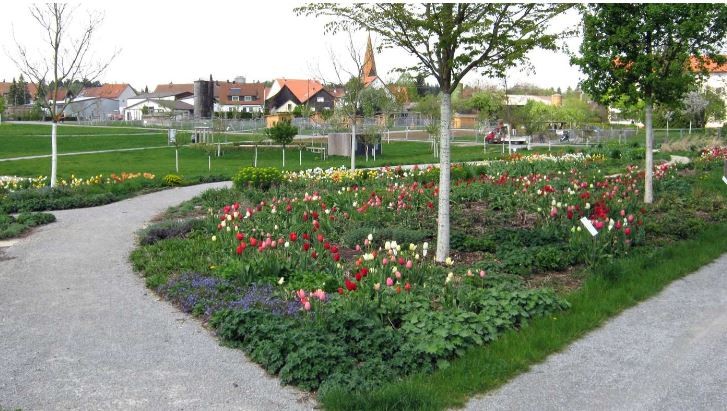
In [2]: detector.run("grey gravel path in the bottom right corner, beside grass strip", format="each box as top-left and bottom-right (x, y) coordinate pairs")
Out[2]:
(466, 254), (727, 410)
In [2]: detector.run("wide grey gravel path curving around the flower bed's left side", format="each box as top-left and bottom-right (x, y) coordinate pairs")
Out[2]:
(0, 183), (315, 410)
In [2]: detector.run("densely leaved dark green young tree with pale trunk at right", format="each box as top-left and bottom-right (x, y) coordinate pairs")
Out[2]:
(572, 3), (727, 203)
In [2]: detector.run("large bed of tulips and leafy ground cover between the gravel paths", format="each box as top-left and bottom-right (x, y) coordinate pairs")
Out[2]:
(132, 143), (727, 408)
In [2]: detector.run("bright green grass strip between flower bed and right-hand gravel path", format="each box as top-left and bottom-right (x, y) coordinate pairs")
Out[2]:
(319, 224), (727, 410)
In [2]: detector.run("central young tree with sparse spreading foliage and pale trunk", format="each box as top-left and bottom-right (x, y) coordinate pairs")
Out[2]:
(296, 3), (571, 261)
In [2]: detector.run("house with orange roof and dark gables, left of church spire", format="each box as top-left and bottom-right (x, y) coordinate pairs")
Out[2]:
(265, 79), (334, 114)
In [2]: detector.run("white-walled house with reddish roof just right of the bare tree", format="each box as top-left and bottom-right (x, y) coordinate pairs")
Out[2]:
(63, 83), (136, 120)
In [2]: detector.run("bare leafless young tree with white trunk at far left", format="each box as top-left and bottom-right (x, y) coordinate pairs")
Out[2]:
(10, 3), (118, 187)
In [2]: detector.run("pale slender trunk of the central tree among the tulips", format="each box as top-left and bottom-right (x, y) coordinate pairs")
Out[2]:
(436, 93), (452, 262)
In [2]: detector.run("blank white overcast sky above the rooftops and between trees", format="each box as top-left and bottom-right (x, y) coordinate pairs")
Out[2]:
(0, 1), (580, 90)
